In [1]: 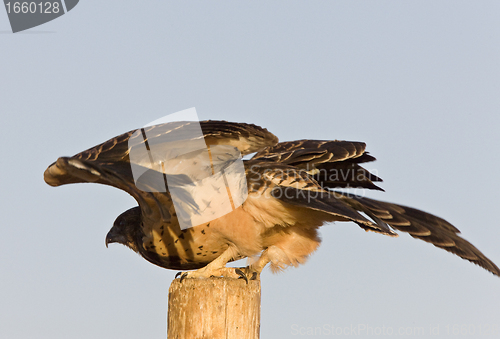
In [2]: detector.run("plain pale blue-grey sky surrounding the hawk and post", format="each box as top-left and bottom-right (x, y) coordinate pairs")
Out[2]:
(0, 0), (500, 339)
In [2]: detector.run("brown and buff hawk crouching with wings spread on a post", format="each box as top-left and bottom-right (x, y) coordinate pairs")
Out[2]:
(44, 121), (500, 279)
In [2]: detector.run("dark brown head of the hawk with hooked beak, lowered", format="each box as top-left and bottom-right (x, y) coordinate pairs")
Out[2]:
(106, 206), (142, 252)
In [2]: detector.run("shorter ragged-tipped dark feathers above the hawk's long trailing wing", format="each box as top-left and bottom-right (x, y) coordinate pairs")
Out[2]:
(252, 140), (383, 191)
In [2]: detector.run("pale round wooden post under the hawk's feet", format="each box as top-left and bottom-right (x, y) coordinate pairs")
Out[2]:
(167, 278), (260, 339)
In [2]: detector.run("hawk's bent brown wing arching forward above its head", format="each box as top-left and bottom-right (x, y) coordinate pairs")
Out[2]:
(44, 121), (278, 220)
